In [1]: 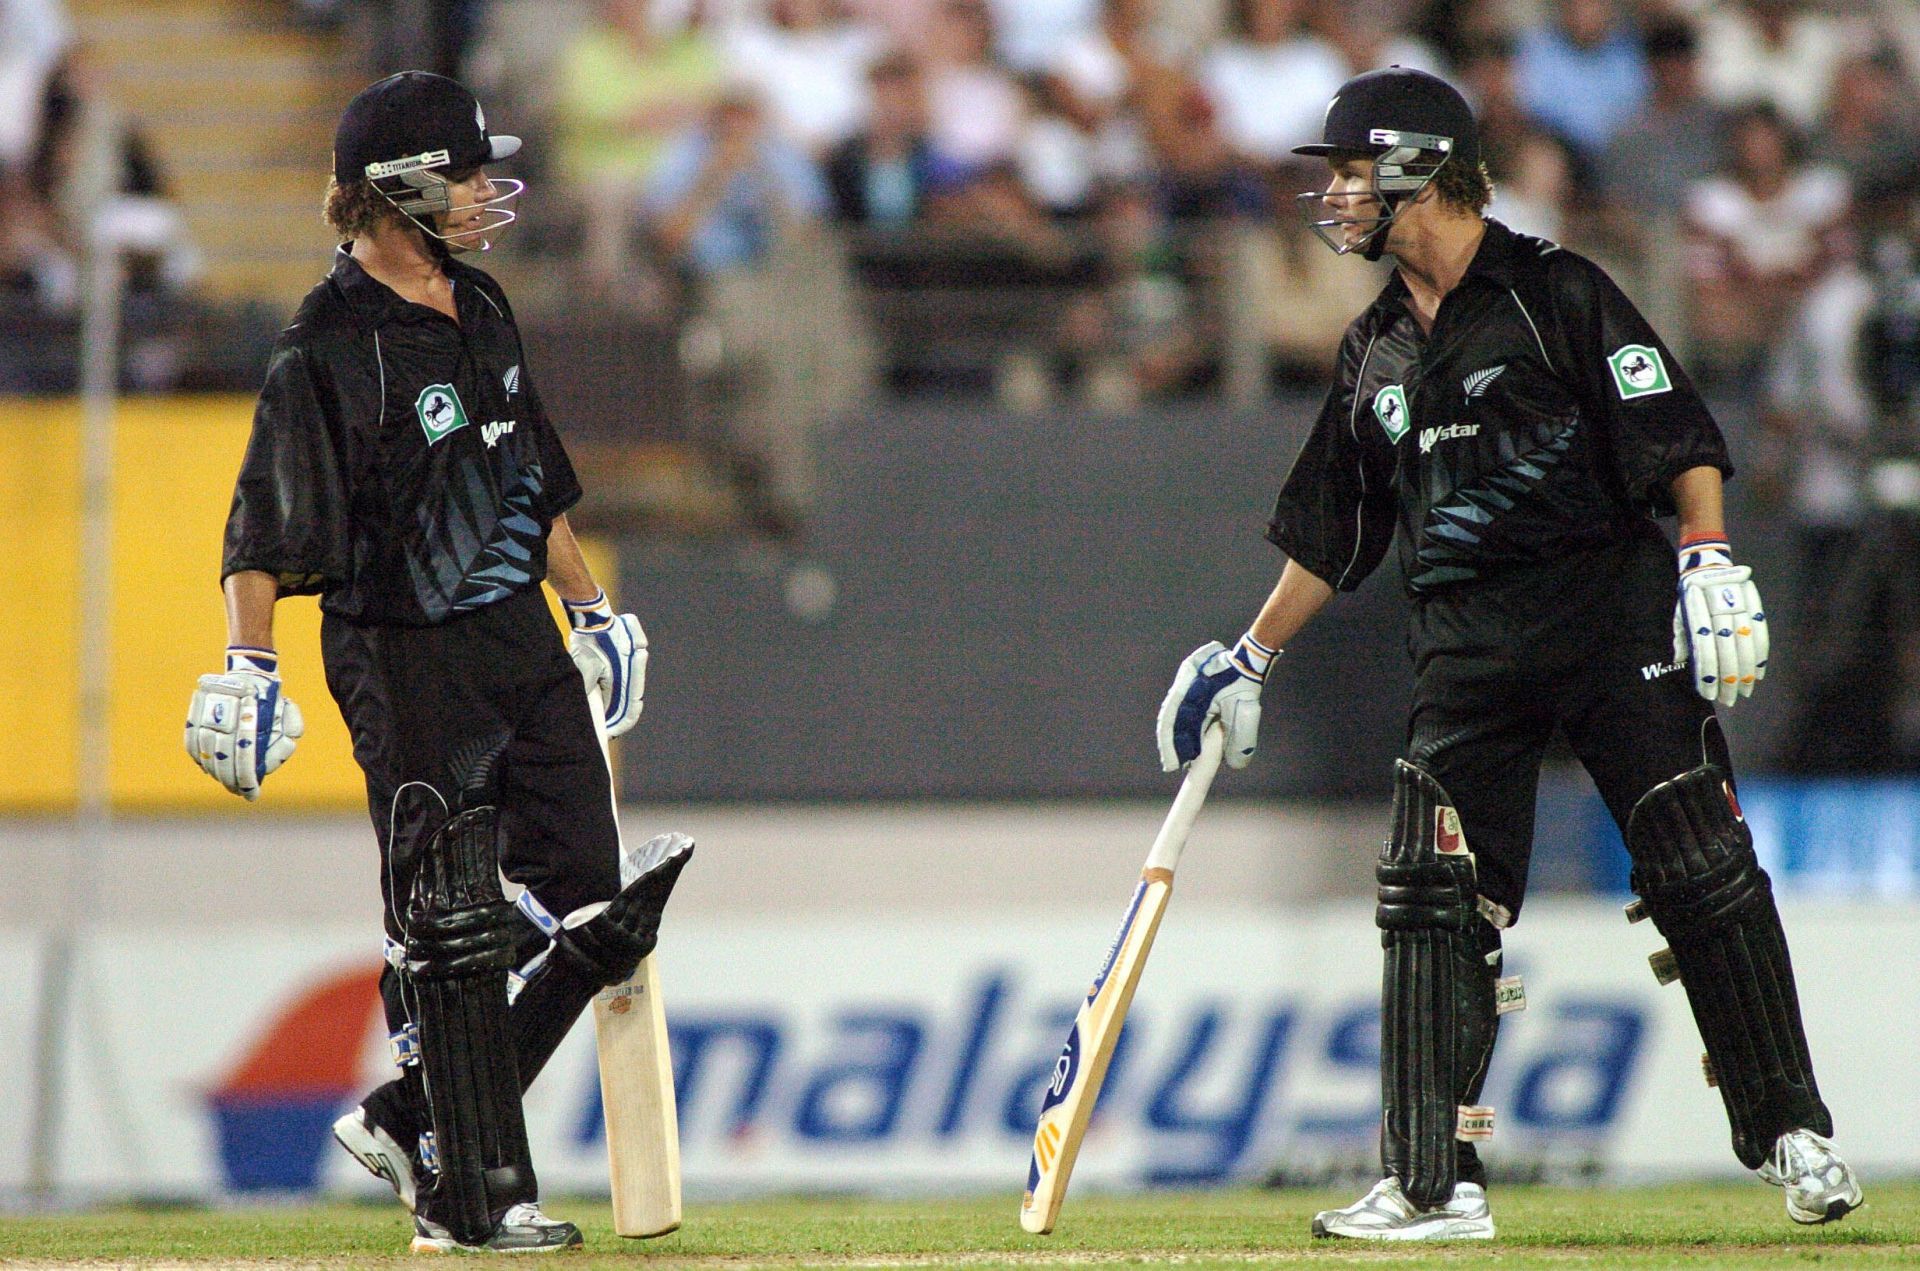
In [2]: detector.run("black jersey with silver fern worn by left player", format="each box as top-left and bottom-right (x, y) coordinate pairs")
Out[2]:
(221, 248), (580, 626)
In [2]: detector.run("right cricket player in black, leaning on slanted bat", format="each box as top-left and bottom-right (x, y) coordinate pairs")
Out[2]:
(1158, 67), (1860, 1240)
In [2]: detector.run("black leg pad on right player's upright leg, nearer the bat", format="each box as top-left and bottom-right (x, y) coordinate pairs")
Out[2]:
(1375, 760), (1500, 1210)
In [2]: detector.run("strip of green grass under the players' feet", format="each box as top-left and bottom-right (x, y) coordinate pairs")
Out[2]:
(0, 1183), (1920, 1271)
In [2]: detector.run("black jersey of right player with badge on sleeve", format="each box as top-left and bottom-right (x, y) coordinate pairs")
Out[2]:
(1267, 221), (1732, 597)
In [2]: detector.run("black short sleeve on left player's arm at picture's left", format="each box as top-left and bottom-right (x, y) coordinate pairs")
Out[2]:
(221, 337), (351, 595)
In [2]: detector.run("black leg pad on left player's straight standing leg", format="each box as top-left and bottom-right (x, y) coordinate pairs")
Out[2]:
(405, 806), (538, 1244)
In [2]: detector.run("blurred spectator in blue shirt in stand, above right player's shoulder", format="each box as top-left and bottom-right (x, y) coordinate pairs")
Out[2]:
(1515, 0), (1647, 156)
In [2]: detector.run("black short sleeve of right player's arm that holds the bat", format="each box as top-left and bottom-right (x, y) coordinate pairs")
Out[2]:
(1267, 332), (1396, 591)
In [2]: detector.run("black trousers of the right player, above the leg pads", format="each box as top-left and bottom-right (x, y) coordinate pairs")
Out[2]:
(1407, 526), (1732, 918)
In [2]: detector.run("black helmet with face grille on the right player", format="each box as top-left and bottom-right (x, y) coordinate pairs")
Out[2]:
(1294, 65), (1480, 261)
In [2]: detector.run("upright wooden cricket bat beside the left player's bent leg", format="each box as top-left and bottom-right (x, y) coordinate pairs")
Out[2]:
(588, 689), (680, 1238)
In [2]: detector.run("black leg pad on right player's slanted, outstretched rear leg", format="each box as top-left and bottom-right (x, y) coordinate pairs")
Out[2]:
(1626, 764), (1834, 1169)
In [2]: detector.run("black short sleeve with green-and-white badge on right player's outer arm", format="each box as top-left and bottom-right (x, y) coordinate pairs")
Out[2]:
(1553, 253), (1734, 516)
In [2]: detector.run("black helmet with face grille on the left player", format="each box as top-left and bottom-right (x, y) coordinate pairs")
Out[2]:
(334, 71), (526, 252)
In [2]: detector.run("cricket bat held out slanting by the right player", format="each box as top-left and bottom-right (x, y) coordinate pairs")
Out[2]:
(1020, 726), (1225, 1236)
